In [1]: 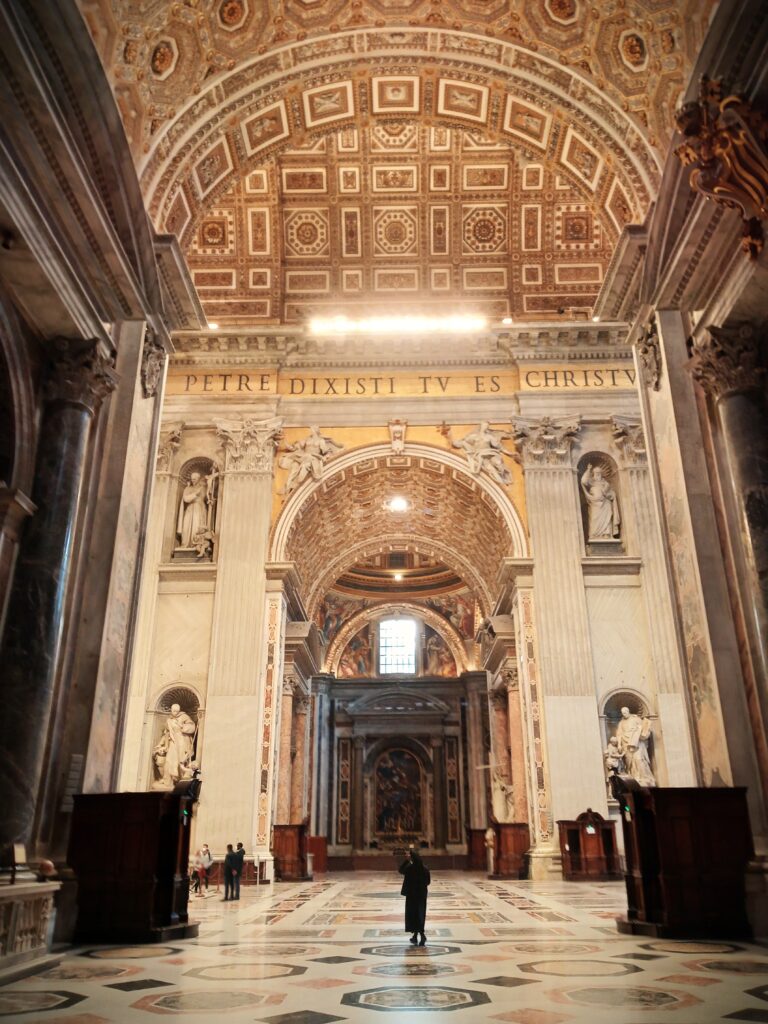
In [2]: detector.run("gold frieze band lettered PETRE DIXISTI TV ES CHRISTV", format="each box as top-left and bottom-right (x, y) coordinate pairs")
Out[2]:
(166, 364), (635, 400)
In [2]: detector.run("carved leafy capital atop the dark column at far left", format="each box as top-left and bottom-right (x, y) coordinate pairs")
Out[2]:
(44, 338), (120, 415)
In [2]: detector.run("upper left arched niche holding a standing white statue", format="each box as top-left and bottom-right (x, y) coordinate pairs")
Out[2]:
(171, 456), (220, 562)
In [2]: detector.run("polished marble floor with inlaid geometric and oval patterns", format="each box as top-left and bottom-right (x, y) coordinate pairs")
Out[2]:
(0, 872), (768, 1024)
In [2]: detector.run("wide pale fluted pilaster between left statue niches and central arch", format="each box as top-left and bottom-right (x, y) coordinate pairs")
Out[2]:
(197, 418), (281, 855)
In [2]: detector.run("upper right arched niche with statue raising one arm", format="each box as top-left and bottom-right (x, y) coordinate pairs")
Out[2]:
(577, 452), (624, 555)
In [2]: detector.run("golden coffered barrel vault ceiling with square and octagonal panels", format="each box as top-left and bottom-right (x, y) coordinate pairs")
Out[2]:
(81, 0), (713, 324)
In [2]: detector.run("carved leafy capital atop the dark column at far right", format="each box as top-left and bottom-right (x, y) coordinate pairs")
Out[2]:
(688, 323), (766, 401)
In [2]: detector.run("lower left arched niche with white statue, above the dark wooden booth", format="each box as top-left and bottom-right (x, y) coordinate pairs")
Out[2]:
(146, 682), (204, 790)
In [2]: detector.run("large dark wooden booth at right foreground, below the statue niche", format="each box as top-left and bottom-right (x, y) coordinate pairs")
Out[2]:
(614, 787), (754, 939)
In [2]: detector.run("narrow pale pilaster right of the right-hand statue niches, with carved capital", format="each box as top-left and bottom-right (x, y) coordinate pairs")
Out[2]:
(611, 416), (697, 785)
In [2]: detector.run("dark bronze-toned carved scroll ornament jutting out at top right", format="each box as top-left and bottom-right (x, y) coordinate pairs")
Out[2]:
(675, 76), (768, 259)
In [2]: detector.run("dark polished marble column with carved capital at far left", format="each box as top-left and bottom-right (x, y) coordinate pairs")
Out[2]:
(0, 340), (117, 850)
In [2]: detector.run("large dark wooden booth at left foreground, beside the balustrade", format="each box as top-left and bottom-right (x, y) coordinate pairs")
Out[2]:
(68, 793), (199, 942)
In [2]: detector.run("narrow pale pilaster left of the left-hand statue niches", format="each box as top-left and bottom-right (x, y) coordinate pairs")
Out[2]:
(118, 423), (183, 792)
